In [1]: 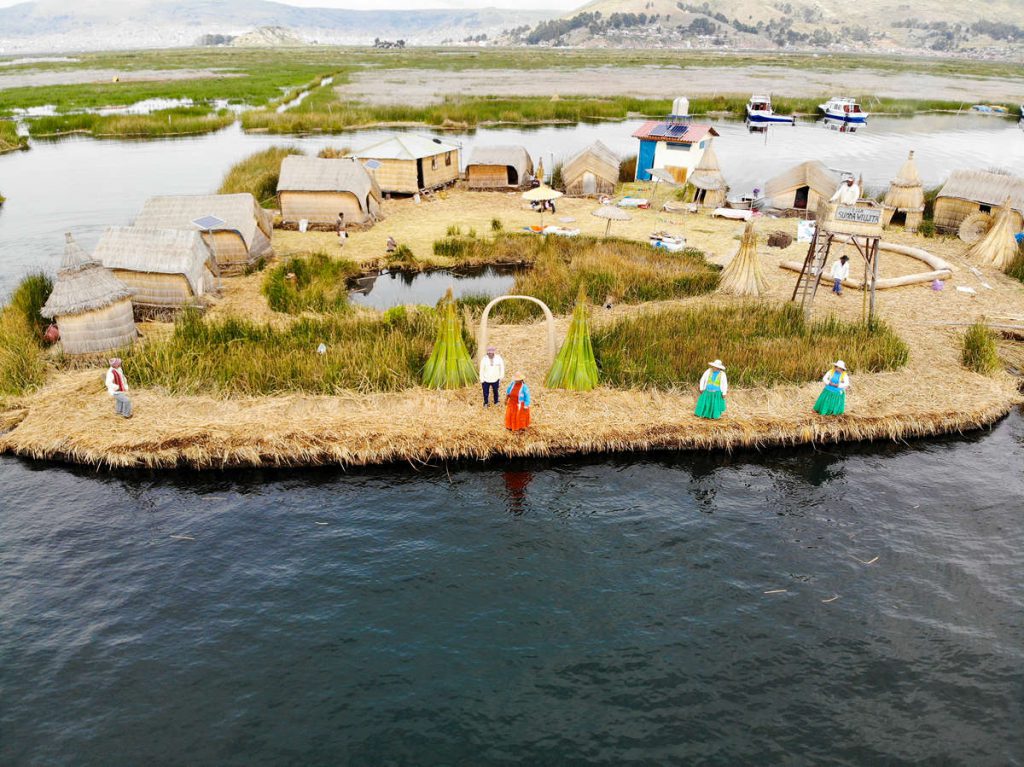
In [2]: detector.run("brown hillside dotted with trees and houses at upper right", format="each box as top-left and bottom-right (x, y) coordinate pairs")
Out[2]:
(508, 0), (1024, 58)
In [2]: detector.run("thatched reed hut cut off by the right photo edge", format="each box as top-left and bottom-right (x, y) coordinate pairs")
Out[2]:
(934, 170), (1024, 232)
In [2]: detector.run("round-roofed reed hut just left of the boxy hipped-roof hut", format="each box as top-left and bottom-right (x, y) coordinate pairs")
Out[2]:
(278, 155), (382, 224)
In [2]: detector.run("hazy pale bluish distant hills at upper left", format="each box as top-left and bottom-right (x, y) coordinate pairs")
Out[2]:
(0, 0), (554, 53)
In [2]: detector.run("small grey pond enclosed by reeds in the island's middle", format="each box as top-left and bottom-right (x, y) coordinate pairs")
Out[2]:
(349, 266), (522, 310)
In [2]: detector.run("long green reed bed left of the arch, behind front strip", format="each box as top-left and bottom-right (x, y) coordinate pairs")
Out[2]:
(125, 303), (472, 396)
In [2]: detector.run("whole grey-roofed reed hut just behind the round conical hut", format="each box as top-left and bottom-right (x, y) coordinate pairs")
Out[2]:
(93, 226), (218, 308)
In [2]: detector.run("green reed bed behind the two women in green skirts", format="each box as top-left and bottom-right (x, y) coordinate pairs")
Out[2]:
(594, 302), (909, 389)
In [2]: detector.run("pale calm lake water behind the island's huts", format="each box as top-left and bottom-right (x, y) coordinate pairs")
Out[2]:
(0, 115), (1024, 294)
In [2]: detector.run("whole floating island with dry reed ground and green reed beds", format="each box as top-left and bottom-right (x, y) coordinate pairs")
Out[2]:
(0, 163), (1024, 469)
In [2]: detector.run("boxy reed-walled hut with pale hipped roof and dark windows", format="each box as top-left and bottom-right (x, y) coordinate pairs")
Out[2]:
(353, 133), (462, 195)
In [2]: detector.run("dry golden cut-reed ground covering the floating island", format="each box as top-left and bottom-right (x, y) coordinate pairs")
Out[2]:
(0, 191), (1024, 468)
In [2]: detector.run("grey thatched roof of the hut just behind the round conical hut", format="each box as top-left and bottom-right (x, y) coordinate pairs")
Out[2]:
(93, 226), (217, 295)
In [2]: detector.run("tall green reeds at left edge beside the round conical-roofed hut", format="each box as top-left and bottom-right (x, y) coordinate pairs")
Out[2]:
(0, 273), (53, 394)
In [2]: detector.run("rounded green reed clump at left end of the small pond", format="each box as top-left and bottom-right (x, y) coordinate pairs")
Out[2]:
(263, 253), (359, 314)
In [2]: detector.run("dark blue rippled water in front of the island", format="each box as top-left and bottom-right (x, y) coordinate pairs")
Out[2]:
(0, 415), (1024, 765)
